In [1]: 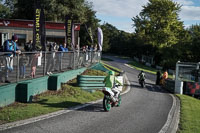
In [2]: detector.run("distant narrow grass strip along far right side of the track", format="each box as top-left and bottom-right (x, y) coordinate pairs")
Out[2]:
(128, 61), (173, 79)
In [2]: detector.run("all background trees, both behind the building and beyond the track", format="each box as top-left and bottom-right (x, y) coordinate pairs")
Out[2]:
(0, 0), (200, 68)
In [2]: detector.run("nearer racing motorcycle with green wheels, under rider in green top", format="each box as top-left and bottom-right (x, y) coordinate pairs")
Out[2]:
(102, 84), (122, 112)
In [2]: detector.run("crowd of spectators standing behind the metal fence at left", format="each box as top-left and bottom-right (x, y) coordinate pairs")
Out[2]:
(0, 35), (98, 83)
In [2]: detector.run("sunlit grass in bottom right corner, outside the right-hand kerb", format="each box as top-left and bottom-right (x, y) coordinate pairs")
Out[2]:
(177, 95), (200, 133)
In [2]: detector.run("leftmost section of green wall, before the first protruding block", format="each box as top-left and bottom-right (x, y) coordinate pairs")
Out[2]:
(0, 83), (17, 107)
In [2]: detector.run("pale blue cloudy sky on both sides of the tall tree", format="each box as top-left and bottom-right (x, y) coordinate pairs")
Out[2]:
(87, 0), (200, 33)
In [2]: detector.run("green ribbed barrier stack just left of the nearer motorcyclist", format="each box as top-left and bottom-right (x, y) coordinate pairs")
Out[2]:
(77, 75), (105, 91)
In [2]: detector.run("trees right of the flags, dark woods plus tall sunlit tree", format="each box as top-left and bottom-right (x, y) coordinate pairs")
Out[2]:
(102, 0), (200, 68)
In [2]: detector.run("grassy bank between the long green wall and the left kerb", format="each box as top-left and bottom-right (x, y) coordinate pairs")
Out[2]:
(0, 70), (106, 124)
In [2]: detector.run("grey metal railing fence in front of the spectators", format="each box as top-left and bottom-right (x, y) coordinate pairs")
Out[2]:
(0, 51), (101, 85)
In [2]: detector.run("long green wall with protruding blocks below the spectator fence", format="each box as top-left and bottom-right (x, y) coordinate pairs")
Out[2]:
(0, 68), (86, 107)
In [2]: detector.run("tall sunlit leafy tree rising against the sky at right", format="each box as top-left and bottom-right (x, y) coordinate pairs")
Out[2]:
(132, 0), (183, 63)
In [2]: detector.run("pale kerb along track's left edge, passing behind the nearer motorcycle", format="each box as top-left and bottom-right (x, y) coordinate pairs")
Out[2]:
(0, 74), (130, 131)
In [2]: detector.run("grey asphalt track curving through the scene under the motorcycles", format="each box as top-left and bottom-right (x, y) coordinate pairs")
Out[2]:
(0, 55), (178, 133)
